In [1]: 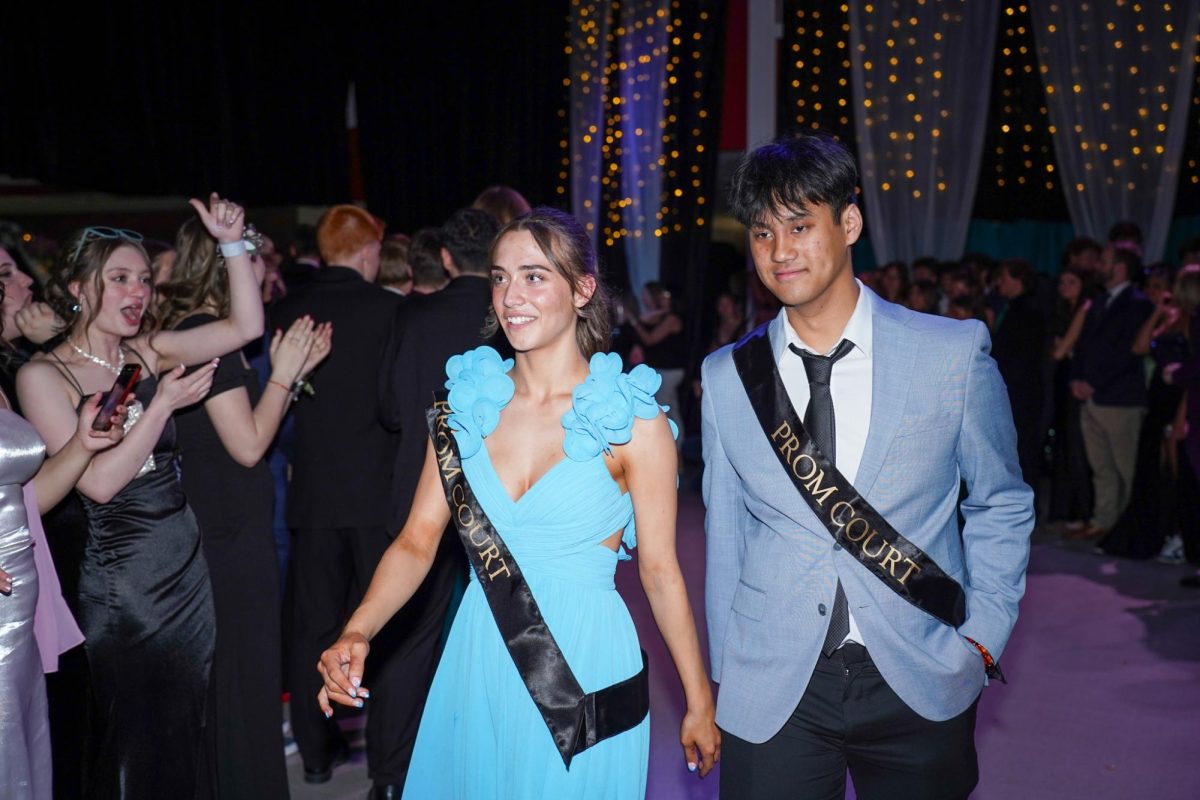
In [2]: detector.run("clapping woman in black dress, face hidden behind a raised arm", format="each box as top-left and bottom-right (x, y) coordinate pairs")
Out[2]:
(158, 219), (331, 800)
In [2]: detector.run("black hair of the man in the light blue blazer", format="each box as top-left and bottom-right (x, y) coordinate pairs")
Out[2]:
(730, 131), (858, 227)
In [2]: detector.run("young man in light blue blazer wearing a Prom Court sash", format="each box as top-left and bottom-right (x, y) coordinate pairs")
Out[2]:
(703, 134), (1033, 800)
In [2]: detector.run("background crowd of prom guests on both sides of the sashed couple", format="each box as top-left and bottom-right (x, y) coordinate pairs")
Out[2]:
(0, 187), (1200, 798)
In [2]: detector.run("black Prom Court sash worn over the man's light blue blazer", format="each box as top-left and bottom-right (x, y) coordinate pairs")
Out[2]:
(733, 326), (966, 627)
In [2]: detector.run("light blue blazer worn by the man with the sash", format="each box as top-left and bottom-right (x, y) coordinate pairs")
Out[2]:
(702, 288), (1033, 744)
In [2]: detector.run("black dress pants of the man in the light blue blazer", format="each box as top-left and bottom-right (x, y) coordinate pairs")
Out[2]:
(721, 644), (979, 800)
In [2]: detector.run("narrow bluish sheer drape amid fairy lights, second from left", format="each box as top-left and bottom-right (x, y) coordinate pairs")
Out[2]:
(619, 0), (671, 296)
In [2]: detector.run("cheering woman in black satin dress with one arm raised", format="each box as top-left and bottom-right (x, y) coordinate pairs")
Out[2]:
(17, 193), (263, 800)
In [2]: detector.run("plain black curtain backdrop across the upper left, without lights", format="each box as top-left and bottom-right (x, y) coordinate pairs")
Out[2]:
(0, 0), (568, 230)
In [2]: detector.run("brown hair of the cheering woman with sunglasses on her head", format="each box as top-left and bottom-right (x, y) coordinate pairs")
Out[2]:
(46, 228), (158, 332)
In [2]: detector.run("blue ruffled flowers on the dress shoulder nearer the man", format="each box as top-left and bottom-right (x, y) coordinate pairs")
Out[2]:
(563, 353), (678, 461)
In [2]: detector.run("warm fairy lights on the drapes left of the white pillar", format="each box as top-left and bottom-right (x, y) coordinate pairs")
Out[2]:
(556, 0), (716, 247)
